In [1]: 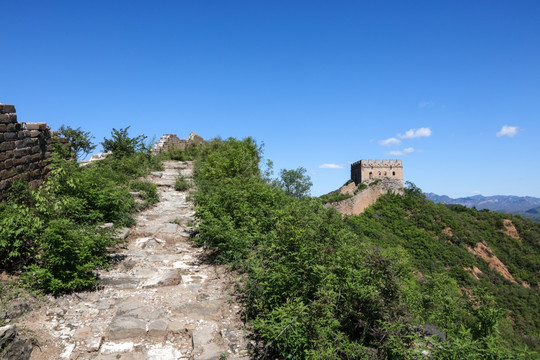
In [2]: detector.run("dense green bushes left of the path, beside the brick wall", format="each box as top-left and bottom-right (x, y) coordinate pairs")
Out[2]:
(0, 127), (160, 293)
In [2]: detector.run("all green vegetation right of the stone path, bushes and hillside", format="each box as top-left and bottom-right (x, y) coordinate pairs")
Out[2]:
(195, 138), (540, 359)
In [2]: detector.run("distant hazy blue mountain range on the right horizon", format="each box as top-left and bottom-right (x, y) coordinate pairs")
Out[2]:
(425, 193), (540, 222)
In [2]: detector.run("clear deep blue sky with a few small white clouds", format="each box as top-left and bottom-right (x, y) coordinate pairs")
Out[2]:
(0, 0), (540, 197)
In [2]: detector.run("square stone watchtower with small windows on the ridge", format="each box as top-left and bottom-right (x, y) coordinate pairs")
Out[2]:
(351, 160), (403, 184)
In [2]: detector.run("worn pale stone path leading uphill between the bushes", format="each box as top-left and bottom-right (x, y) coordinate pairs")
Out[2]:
(20, 161), (248, 360)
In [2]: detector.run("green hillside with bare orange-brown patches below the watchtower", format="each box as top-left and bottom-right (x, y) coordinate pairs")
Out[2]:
(346, 191), (540, 349)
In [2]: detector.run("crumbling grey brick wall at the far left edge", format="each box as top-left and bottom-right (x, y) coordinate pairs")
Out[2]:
(0, 104), (51, 199)
